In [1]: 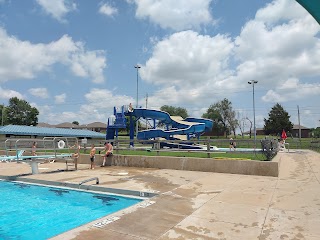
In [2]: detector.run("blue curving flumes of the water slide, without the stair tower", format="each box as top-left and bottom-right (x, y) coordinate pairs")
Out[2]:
(132, 108), (210, 140)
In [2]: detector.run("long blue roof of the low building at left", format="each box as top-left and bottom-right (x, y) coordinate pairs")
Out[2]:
(0, 125), (105, 139)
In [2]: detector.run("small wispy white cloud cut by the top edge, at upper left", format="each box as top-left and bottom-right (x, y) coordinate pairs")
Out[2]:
(36, 0), (77, 22)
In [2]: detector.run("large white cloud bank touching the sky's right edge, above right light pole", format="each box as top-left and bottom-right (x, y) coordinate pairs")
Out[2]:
(234, 0), (320, 95)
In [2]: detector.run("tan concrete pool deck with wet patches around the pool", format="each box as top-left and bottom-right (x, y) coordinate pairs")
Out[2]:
(0, 150), (320, 240)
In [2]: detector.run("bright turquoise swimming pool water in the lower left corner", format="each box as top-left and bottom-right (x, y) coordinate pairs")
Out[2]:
(0, 181), (142, 240)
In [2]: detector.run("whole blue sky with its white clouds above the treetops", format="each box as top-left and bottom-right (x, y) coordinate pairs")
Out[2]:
(0, 0), (320, 131)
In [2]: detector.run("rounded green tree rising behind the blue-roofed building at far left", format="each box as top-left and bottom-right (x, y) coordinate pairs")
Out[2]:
(6, 97), (39, 126)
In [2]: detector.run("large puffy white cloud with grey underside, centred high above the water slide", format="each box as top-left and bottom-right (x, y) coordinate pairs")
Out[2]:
(140, 31), (233, 87)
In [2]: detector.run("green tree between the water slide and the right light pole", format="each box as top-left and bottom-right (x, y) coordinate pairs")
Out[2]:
(202, 98), (238, 136)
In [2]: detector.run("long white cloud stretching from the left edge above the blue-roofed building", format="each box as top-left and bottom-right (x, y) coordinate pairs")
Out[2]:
(0, 28), (106, 83)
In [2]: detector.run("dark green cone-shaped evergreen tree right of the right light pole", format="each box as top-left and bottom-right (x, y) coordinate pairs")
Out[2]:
(263, 103), (293, 136)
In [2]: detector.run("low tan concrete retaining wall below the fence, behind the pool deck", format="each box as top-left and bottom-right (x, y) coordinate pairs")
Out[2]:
(79, 154), (279, 177)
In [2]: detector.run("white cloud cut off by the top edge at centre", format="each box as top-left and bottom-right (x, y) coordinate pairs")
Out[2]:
(135, 0), (213, 30)
